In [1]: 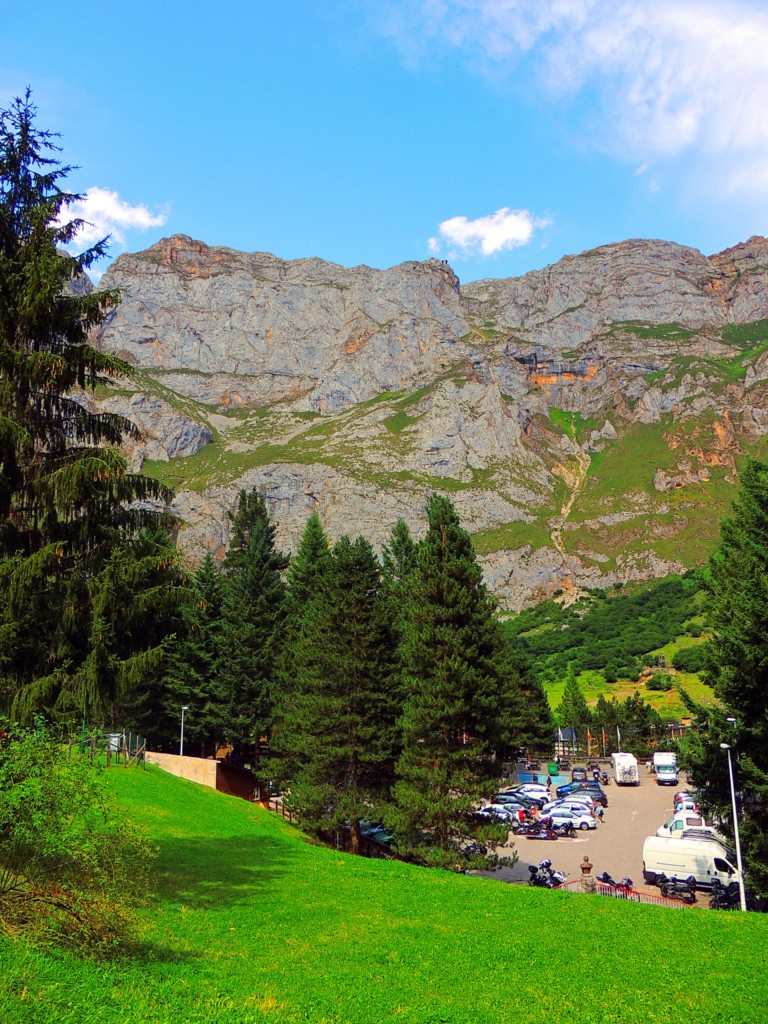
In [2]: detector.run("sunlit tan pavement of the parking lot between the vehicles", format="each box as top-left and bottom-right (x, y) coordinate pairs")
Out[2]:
(492, 773), (685, 889)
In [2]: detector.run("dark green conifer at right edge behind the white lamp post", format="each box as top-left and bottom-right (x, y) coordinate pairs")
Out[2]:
(682, 459), (768, 895)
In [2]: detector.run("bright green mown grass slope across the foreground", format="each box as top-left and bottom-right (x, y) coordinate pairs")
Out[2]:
(0, 768), (768, 1024)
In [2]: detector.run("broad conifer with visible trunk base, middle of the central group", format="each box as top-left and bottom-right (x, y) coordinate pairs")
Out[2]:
(276, 538), (400, 852)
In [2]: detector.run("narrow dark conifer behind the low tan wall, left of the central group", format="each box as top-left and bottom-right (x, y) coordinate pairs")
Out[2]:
(218, 489), (288, 767)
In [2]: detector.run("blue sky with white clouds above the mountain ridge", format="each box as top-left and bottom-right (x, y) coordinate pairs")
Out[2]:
(0, 0), (768, 281)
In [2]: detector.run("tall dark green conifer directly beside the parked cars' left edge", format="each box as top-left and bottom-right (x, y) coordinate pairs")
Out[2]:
(394, 495), (516, 868)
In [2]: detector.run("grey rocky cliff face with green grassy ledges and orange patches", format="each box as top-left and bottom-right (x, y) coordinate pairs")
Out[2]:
(90, 236), (768, 607)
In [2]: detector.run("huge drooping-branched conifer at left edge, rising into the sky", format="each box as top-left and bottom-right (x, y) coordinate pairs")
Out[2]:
(0, 92), (170, 711)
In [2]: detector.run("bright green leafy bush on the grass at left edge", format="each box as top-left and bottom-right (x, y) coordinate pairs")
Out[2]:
(0, 728), (154, 951)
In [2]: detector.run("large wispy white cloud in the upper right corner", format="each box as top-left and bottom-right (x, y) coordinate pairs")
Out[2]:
(385, 0), (768, 193)
